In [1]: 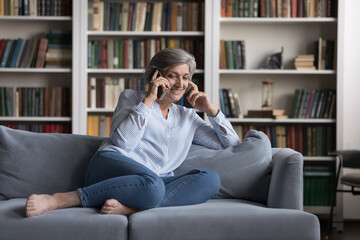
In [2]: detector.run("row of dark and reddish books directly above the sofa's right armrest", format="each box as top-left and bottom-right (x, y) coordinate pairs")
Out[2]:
(233, 124), (336, 156)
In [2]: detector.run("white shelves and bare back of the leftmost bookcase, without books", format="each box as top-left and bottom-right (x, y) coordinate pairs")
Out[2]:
(0, 5), (76, 130)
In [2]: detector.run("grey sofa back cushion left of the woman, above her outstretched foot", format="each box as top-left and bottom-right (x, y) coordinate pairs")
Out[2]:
(0, 126), (103, 199)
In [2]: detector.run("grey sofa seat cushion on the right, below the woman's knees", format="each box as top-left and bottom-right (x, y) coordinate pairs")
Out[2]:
(129, 199), (320, 240)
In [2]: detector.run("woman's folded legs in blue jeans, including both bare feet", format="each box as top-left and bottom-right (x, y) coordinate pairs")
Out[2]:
(26, 151), (220, 217)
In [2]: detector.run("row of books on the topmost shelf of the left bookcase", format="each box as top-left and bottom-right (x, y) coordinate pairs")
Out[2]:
(0, 0), (72, 16)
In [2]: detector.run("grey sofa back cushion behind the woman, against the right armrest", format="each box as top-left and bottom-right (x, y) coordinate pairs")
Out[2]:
(175, 130), (272, 203)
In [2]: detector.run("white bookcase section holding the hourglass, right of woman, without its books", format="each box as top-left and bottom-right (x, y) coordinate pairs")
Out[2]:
(212, 0), (343, 220)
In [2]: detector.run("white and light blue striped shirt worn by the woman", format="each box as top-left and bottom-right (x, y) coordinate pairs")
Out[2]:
(99, 90), (240, 176)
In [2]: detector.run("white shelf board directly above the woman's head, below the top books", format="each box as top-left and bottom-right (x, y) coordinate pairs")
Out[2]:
(87, 31), (204, 37)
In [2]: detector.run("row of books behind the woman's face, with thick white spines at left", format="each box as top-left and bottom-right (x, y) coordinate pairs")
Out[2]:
(88, 77), (204, 109)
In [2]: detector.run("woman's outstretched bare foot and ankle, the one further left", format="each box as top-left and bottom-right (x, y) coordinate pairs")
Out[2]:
(26, 191), (81, 217)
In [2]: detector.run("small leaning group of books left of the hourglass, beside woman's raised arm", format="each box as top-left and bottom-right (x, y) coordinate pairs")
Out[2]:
(219, 88), (243, 118)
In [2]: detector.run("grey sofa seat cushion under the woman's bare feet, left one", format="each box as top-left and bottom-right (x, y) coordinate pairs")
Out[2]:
(0, 199), (128, 240)
